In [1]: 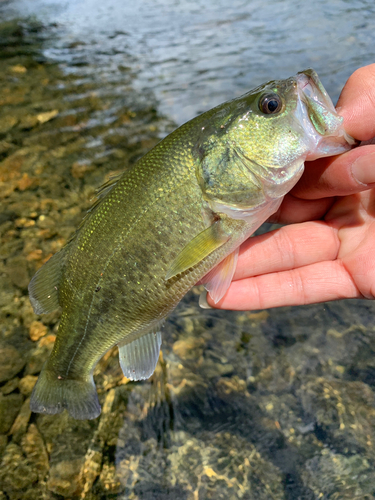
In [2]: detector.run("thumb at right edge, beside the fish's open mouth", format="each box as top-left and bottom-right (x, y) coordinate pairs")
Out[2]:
(337, 64), (375, 141)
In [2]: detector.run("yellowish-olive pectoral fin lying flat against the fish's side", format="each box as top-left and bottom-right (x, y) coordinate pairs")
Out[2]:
(165, 220), (230, 280)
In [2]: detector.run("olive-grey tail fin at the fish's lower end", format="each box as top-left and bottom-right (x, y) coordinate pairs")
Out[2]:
(30, 365), (101, 420)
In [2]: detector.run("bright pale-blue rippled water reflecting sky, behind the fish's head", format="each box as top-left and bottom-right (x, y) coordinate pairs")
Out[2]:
(5, 0), (375, 124)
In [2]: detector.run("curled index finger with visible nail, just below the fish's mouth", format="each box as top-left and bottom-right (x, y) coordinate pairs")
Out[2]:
(291, 145), (375, 200)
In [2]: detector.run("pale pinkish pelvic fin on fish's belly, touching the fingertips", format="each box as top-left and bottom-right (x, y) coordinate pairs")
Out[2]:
(204, 248), (239, 304)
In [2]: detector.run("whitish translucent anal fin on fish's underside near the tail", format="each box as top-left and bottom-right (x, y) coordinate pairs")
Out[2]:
(118, 331), (161, 380)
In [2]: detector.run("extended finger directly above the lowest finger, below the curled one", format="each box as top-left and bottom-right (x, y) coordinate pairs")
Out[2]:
(233, 222), (340, 280)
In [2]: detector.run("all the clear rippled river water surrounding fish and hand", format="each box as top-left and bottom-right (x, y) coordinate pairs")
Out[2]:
(0, 0), (375, 500)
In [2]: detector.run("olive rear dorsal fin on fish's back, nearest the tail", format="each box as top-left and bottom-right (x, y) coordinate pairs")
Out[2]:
(29, 245), (69, 314)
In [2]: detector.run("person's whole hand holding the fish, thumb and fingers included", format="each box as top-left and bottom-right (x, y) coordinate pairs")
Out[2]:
(200, 64), (375, 310)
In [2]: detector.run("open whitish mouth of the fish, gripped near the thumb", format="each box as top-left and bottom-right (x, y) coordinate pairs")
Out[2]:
(296, 69), (356, 160)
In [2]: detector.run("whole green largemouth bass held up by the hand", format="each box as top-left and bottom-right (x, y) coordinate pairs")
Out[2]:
(29, 69), (354, 419)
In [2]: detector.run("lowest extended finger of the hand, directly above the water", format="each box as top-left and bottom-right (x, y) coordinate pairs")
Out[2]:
(206, 260), (362, 311)
